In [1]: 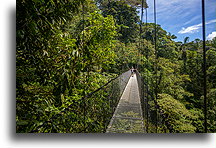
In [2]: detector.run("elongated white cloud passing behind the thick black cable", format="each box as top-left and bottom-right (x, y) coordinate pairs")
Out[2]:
(178, 19), (216, 34)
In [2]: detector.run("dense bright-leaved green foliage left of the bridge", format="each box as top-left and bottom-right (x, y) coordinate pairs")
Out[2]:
(16, 0), (119, 132)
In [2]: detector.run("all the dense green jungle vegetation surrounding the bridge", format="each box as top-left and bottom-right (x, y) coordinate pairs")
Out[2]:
(16, 0), (216, 133)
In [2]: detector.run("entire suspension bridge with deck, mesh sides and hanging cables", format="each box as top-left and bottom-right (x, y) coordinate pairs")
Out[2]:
(28, 0), (207, 133)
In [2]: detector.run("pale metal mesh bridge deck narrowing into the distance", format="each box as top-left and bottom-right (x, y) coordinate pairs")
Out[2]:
(106, 74), (144, 133)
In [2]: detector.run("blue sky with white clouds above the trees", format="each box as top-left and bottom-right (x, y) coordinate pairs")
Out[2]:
(138, 0), (216, 41)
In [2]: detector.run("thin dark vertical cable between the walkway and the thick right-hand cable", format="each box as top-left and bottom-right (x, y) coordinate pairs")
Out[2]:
(154, 0), (158, 133)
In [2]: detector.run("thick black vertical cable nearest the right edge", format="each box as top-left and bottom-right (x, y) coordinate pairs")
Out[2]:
(202, 0), (208, 133)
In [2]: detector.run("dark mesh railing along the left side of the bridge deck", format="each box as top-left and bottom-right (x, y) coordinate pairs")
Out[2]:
(31, 70), (131, 133)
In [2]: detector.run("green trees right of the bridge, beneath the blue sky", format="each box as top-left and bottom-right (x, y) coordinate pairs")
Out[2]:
(142, 23), (216, 132)
